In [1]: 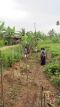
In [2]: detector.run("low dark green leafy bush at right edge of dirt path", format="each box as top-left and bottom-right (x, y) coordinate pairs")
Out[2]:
(45, 61), (60, 87)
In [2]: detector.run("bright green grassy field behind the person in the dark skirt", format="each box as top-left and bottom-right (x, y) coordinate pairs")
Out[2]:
(37, 42), (60, 57)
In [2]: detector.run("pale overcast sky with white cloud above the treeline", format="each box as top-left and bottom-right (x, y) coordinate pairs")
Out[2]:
(0, 0), (60, 33)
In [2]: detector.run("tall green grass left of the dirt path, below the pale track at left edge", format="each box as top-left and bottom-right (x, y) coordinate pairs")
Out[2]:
(0, 45), (22, 68)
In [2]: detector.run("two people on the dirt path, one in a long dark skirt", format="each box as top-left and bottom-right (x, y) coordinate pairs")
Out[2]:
(24, 46), (46, 65)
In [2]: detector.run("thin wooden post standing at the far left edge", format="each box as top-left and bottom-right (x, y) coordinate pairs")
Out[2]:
(0, 51), (4, 107)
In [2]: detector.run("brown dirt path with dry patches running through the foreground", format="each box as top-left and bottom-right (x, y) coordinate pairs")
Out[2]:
(0, 53), (57, 107)
